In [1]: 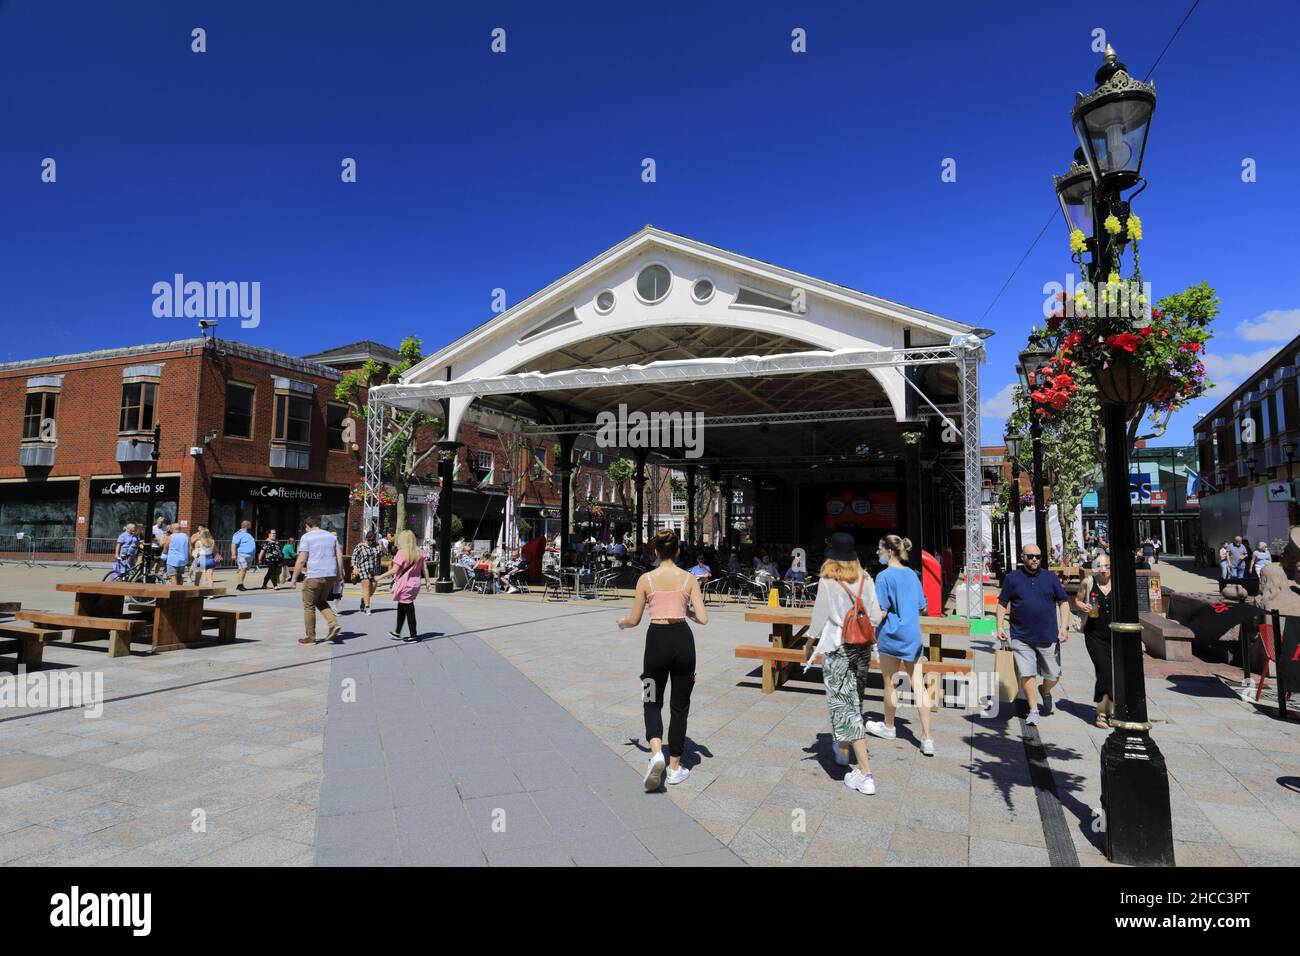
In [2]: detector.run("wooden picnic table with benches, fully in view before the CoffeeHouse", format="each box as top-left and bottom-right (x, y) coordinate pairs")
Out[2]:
(17, 581), (226, 652)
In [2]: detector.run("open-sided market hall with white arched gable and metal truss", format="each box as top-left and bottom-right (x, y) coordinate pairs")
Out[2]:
(365, 225), (991, 615)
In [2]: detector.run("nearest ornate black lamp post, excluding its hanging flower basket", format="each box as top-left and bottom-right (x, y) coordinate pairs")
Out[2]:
(1054, 47), (1174, 866)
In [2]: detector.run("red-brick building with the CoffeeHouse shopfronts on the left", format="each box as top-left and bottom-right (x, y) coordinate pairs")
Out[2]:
(0, 338), (364, 555)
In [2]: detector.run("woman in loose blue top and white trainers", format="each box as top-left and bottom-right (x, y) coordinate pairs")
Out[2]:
(866, 535), (937, 757)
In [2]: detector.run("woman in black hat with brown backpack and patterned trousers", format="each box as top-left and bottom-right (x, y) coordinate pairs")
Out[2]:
(805, 532), (880, 796)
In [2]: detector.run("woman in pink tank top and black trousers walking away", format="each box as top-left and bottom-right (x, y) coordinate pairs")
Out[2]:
(618, 529), (709, 791)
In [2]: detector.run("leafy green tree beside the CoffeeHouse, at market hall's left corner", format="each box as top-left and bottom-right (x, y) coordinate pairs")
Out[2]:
(334, 336), (442, 531)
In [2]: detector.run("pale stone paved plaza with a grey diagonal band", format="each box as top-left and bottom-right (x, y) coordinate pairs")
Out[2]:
(0, 566), (1300, 866)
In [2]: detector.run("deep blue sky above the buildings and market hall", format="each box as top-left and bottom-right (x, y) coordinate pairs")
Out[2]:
(0, 0), (1300, 444)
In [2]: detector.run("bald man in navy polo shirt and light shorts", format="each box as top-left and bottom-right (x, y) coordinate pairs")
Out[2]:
(997, 545), (1070, 726)
